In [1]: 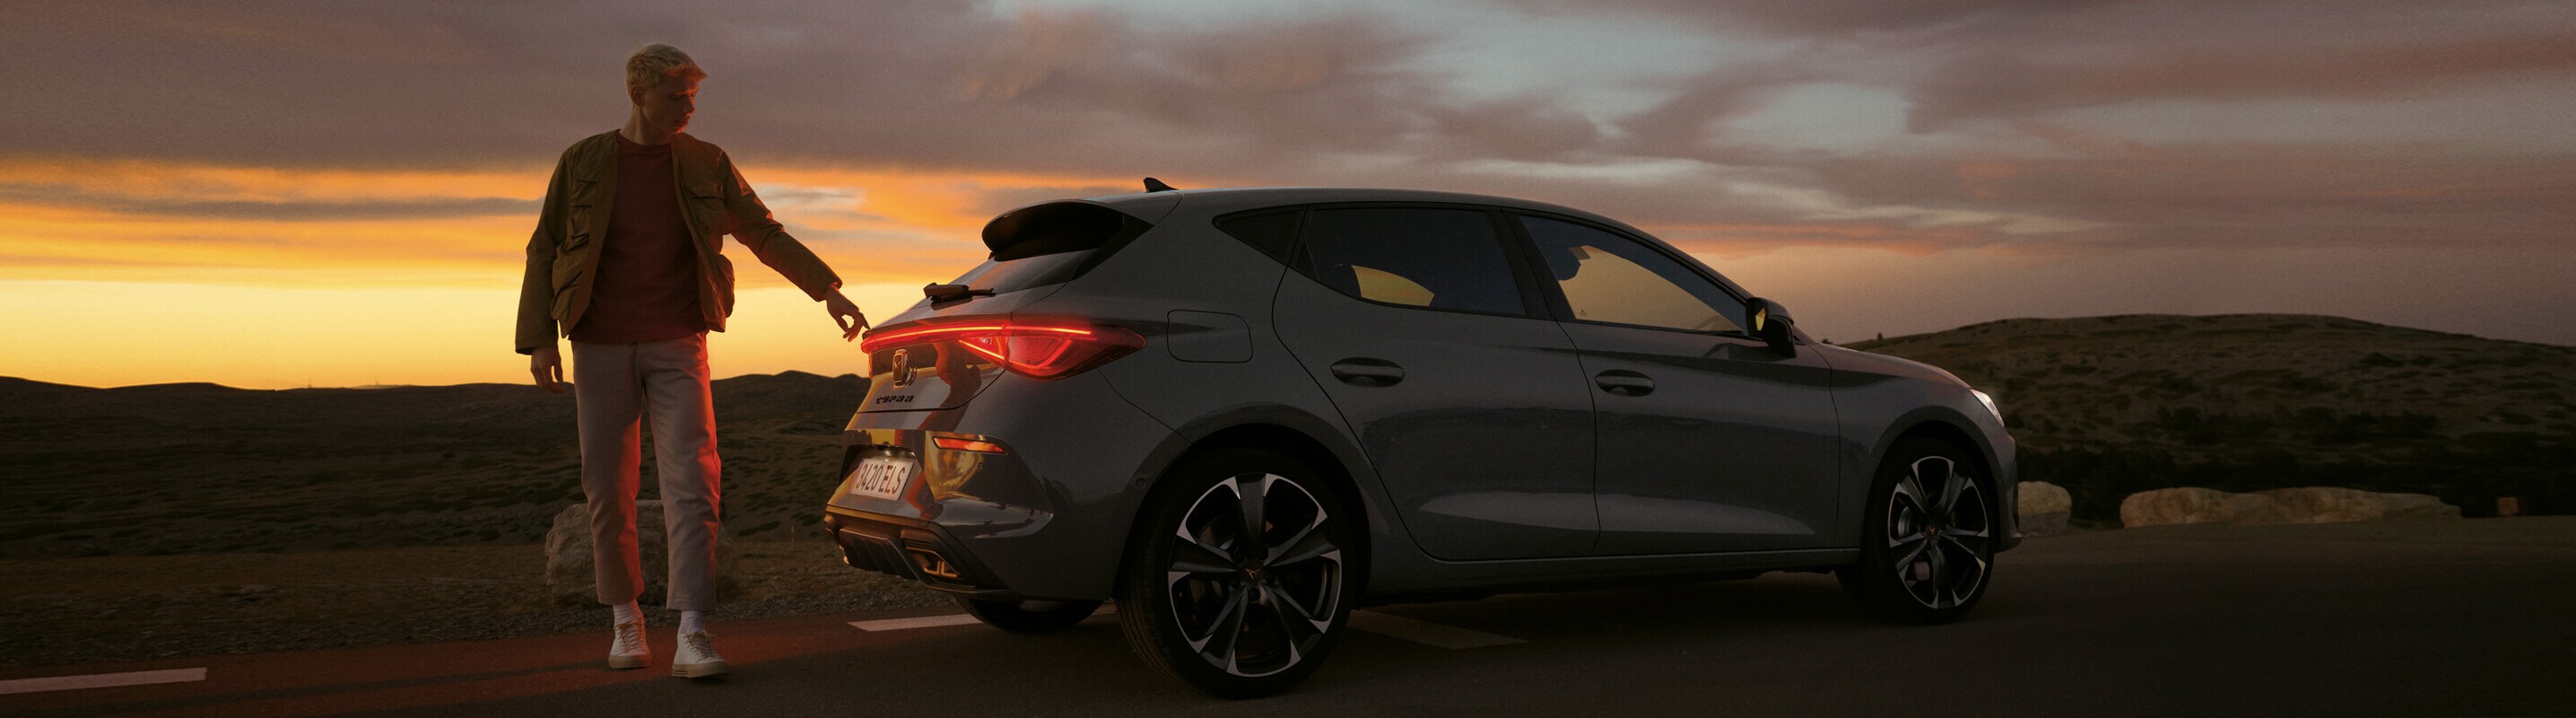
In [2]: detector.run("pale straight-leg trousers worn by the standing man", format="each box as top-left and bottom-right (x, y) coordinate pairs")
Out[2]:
(572, 332), (724, 610)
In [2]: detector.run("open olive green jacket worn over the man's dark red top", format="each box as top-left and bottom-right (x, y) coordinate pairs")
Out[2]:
(518, 131), (840, 355)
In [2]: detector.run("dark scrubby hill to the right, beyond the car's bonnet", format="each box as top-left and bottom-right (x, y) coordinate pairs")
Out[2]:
(1849, 314), (2576, 520)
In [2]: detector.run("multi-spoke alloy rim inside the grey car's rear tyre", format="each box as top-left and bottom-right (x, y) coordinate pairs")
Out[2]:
(1164, 474), (1345, 677)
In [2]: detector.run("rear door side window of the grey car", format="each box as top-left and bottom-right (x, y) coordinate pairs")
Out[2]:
(1306, 208), (1527, 314)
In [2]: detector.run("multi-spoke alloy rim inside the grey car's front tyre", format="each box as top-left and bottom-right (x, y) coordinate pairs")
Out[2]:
(1885, 456), (1994, 610)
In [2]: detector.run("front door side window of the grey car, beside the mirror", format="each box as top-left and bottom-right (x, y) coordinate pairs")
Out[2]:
(1519, 216), (1744, 332)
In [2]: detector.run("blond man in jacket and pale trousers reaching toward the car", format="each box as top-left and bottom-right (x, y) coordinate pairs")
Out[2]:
(518, 44), (868, 677)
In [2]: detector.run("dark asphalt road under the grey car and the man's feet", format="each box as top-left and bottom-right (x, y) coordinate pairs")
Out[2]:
(0, 517), (2576, 715)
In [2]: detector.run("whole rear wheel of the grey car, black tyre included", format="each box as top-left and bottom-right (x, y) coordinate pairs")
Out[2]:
(1118, 448), (1358, 697)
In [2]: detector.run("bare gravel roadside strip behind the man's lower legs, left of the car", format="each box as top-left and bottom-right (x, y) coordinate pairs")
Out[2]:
(0, 540), (948, 667)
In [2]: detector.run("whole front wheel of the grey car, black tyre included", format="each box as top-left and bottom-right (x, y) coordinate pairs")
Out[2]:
(1834, 437), (2002, 626)
